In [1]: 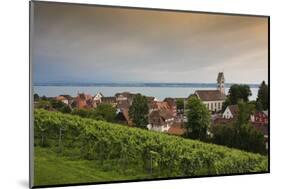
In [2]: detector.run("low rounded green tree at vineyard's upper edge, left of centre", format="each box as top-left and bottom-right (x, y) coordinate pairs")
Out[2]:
(94, 104), (117, 122)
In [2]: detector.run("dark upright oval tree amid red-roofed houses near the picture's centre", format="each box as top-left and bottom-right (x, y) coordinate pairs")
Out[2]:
(129, 94), (149, 128)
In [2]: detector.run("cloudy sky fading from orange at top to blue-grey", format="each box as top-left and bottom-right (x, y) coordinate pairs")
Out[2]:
(31, 2), (268, 83)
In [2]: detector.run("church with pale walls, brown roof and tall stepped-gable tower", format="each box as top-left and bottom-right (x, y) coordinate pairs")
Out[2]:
(195, 72), (226, 112)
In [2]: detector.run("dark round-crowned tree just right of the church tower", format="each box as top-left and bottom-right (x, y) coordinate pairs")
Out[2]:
(228, 84), (252, 104)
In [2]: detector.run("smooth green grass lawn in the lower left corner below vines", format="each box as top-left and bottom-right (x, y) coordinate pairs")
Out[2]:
(34, 147), (148, 186)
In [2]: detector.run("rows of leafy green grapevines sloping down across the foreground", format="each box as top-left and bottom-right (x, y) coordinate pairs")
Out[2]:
(34, 109), (268, 185)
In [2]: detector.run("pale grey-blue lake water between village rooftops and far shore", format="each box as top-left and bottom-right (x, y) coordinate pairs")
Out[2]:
(33, 86), (258, 100)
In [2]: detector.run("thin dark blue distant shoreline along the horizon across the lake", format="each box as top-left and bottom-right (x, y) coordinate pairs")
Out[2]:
(33, 83), (260, 88)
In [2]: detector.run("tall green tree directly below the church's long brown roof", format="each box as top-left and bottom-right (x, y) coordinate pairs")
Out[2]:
(186, 97), (211, 140)
